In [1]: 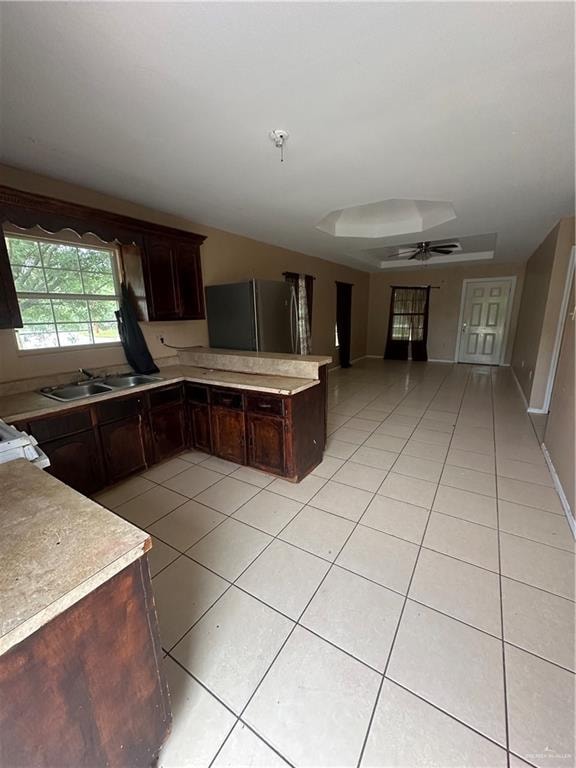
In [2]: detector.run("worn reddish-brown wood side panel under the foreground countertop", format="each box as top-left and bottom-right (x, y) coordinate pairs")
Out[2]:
(0, 556), (172, 768)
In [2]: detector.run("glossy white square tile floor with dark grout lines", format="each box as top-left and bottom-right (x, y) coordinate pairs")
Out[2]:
(92, 360), (576, 768)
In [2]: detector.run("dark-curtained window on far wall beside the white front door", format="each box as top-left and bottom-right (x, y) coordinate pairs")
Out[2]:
(384, 285), (430, 361)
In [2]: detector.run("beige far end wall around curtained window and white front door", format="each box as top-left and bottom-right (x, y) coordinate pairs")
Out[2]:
(367, 262), (524, 362)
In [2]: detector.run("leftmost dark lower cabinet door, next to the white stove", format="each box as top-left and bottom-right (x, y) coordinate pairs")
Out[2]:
(40, 430), (104, 496)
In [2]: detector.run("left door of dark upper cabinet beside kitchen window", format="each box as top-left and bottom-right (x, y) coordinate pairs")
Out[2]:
(144, 237), (180, 320)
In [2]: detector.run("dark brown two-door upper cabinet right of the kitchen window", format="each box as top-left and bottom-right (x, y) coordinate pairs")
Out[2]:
(136, 235), (204, 320)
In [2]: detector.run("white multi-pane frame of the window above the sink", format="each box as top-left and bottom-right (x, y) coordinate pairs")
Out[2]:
(3, 227), (121, 356)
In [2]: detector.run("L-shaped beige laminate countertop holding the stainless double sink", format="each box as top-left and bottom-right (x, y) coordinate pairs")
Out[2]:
(0, 365), (319, 422)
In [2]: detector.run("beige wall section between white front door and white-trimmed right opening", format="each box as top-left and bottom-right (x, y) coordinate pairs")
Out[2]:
(512, 217), (574, 409)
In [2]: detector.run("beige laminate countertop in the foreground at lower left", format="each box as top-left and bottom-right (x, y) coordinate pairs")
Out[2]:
(0, 459), (150, 654)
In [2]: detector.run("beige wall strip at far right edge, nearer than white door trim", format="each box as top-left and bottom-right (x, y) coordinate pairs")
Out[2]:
(544, 278), (576, 517)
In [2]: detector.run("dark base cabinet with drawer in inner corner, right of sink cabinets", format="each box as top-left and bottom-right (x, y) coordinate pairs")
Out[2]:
(149, 385), (186, 464)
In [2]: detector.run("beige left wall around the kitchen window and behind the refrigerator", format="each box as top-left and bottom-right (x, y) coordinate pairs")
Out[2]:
(0, 165), (369, 382)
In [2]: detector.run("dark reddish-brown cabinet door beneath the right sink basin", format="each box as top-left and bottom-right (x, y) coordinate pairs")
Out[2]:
(100, 416), (146, 483)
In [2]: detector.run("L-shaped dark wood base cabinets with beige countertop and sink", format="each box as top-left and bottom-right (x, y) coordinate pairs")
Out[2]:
(0, 347), (331, 495)
